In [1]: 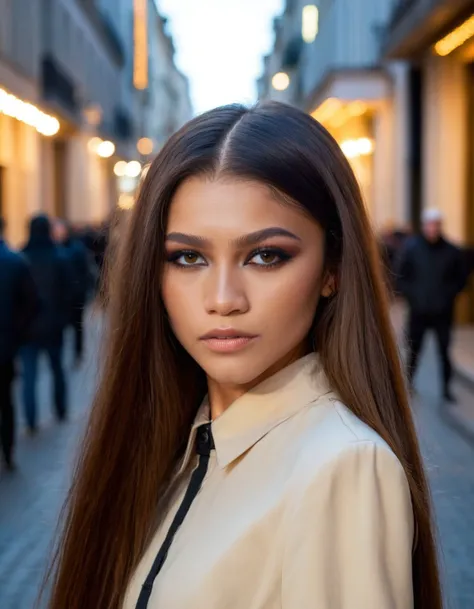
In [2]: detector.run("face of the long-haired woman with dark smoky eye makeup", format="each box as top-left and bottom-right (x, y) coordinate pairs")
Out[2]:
(162, 177), (330, 386)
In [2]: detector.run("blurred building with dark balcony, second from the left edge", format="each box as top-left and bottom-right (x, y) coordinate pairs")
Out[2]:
(41, 0), (134, 224)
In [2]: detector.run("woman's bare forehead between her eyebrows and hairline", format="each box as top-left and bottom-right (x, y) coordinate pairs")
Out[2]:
(167, 177), (321, 235)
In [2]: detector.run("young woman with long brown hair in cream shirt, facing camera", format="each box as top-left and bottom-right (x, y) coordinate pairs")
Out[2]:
(44, 103), (441, 609)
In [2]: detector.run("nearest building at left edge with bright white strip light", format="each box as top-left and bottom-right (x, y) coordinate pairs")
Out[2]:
(0, 0), (51, 244)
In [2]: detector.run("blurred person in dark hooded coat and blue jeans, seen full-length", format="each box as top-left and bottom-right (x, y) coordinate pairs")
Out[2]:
(22, 215), (73, 433)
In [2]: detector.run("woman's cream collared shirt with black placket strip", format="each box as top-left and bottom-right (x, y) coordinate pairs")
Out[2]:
(124, 354), (413, 609)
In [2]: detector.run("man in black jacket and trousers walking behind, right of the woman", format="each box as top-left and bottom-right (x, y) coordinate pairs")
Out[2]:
(398, 209), (467, 401)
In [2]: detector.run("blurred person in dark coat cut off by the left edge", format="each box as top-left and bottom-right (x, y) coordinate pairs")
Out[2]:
(0, 218), (39, 470)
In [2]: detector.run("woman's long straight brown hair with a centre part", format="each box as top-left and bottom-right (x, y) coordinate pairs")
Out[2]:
(49, 103), (442, 609)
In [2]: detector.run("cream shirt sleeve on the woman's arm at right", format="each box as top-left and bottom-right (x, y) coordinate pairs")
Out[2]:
(282, 442), (413, 609)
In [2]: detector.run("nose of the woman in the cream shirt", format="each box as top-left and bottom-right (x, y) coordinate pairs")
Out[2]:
(204, 267), (250, 316)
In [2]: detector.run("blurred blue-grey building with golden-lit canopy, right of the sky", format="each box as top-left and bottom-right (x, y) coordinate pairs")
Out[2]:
(258, 0), (408, 229)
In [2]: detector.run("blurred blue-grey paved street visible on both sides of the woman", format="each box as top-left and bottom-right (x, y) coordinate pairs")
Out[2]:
(0, 321), (474, 609)
